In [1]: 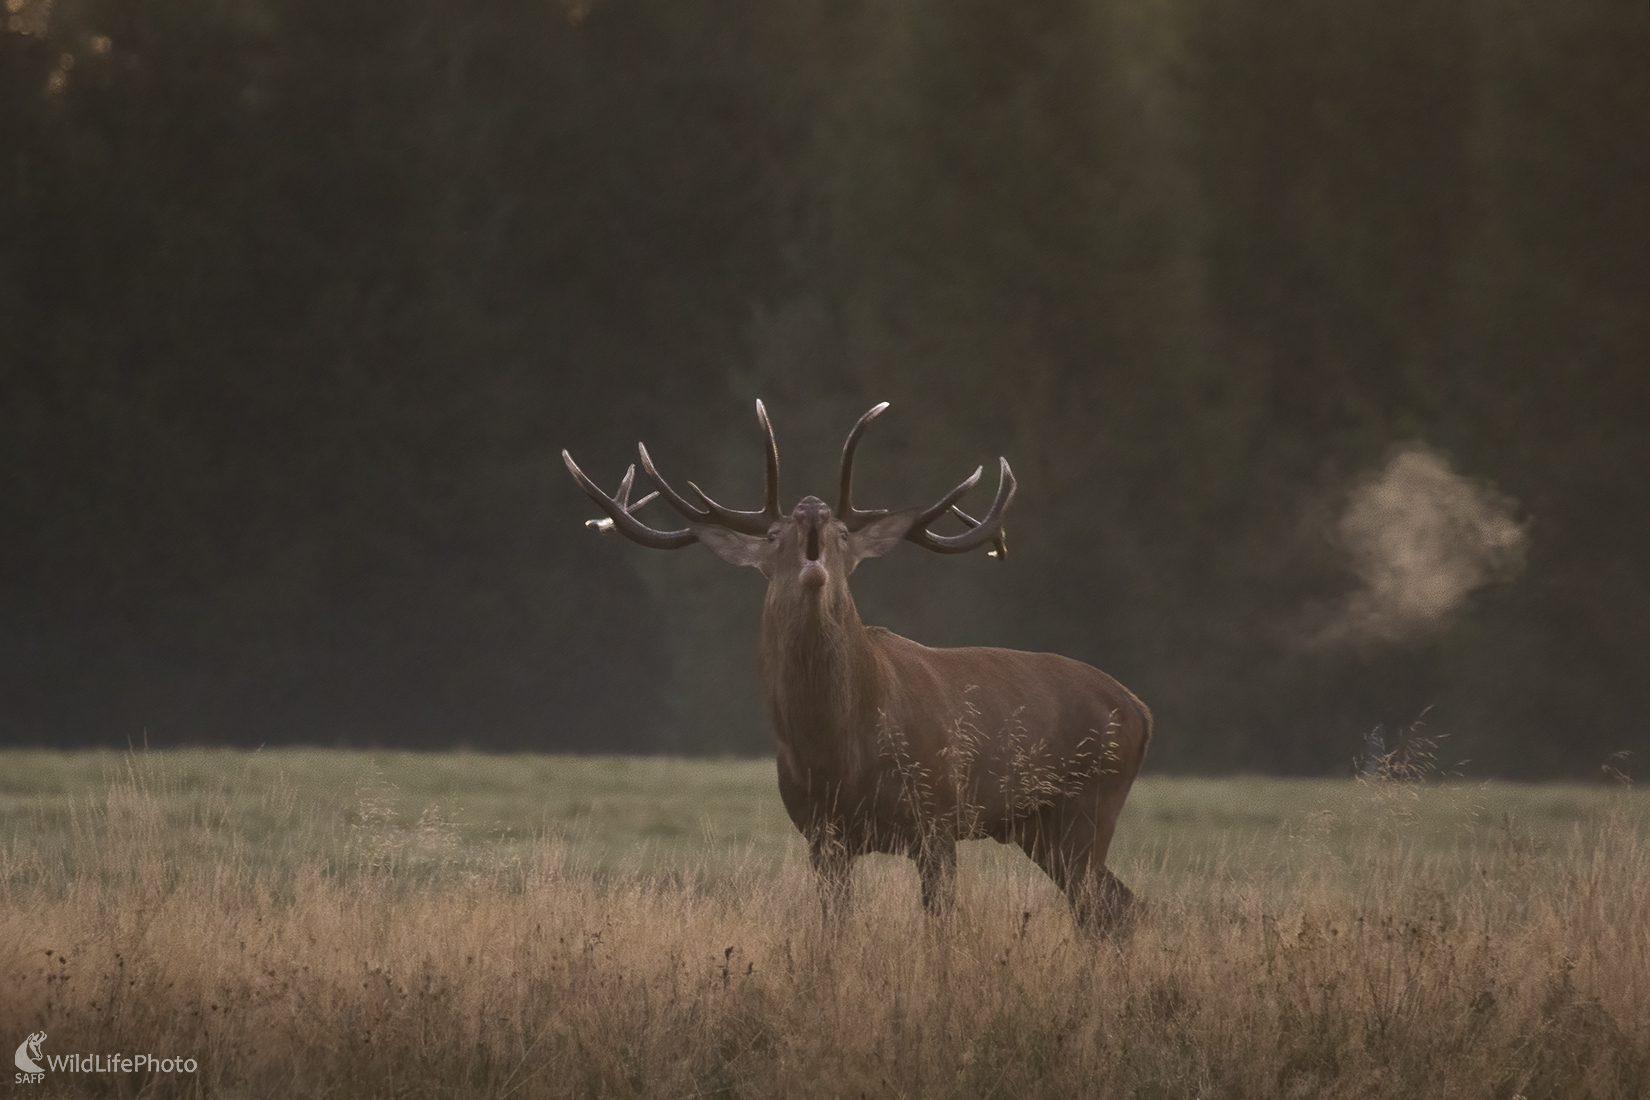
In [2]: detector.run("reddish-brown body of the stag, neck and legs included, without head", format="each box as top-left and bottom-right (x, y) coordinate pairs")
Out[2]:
(761, 511), (1152, 924)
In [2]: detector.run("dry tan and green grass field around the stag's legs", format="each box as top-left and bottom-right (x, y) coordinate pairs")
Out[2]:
(0, 750), (1650, 1100)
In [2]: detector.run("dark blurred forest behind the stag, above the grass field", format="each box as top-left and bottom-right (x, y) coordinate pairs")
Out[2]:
(0, 0), (1650, 777)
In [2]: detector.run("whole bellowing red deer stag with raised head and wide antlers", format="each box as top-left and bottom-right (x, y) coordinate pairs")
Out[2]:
(561, 401), (1152, 930)
